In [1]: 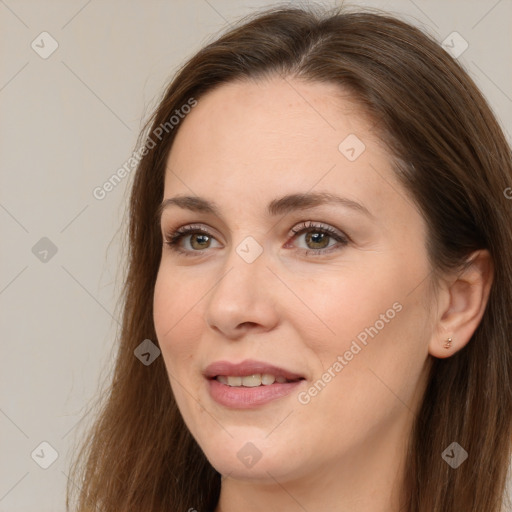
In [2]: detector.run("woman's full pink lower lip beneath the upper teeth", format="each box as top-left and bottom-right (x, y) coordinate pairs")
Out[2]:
(209, 379), (303, 409)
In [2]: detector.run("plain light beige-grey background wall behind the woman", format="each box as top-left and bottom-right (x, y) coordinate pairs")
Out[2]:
(0, 0), (512, 512)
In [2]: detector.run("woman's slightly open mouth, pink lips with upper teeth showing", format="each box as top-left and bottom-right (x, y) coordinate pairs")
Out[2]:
(204, 360), (306, 409)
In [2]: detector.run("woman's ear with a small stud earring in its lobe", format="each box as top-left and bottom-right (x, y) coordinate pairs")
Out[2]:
(429, 250), (494, 359)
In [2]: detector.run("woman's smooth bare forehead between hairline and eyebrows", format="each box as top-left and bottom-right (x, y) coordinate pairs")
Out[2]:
(165, 78), (408, 220)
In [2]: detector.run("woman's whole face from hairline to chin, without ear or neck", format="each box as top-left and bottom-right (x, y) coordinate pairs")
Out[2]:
(154, 78), (433, 482)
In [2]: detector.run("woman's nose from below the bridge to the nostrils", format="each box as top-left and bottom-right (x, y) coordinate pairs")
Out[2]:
(205, 244), (279, 339)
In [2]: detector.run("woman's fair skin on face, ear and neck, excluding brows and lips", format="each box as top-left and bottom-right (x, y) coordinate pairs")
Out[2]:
(154, 77), (492, 512)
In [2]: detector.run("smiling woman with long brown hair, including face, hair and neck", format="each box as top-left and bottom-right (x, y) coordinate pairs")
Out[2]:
(67, 4), (512, 512)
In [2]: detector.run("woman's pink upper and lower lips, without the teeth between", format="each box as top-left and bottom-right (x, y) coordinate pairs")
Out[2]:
(203, 359), (304, 409)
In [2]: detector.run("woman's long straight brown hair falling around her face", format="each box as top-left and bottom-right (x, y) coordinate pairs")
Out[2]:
(67, 7), (512, 512)
